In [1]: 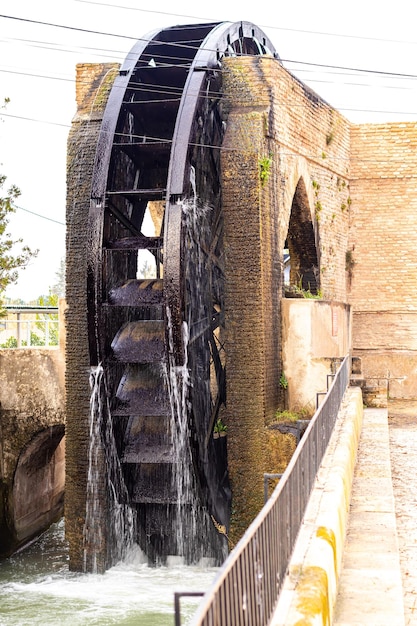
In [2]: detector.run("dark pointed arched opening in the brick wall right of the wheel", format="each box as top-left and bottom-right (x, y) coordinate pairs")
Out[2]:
(284, 178), (320, 296)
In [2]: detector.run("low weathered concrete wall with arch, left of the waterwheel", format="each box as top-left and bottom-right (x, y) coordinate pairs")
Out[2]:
(0, 301), (65, 557)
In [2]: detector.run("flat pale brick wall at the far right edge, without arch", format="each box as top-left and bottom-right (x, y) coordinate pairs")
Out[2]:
(349, 123), (417, 403)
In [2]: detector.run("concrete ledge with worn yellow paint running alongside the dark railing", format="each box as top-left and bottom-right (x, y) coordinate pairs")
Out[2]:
(270, 388), (363, 626)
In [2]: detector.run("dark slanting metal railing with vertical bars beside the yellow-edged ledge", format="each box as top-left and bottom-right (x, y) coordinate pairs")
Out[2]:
(191, 356), (350, 626)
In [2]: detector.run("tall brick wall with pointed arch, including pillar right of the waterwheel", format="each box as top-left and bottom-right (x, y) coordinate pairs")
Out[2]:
(222, 57), (351, 541)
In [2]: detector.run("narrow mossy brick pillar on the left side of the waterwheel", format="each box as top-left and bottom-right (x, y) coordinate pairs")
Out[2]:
(65, 63), (119, 570)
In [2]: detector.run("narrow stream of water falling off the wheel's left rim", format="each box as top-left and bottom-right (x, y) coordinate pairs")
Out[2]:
(83, 364), (136, 573)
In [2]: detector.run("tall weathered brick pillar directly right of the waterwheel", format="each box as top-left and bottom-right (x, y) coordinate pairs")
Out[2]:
(221, 57), (282, 545)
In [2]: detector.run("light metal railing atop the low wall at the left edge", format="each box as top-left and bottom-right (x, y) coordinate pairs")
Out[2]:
(0, 306), (59, 349)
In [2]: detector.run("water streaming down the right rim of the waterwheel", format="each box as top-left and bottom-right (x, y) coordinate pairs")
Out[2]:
(162, 168), (227, 562)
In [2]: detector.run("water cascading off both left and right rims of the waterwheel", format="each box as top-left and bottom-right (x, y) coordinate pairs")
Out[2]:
(83, 194), (227, 572)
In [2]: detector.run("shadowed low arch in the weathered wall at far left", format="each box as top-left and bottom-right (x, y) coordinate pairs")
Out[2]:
(12, 424), (65, 544)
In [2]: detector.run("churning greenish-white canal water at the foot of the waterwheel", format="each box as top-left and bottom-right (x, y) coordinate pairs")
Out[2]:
(0, 520), (218, 626)
